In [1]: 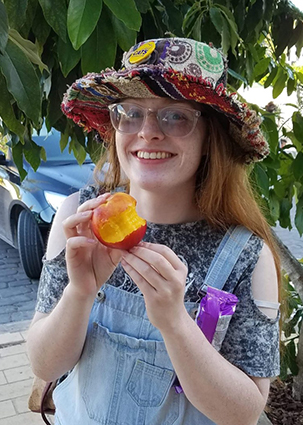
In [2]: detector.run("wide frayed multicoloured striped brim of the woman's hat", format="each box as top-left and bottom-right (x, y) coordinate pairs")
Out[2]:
(62, 65), (269, 163)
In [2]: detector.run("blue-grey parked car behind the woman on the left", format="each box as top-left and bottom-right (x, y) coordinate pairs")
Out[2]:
(0, 128), (94, 279)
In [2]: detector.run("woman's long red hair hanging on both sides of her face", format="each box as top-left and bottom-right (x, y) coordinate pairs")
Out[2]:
(95, 105), (281, 282)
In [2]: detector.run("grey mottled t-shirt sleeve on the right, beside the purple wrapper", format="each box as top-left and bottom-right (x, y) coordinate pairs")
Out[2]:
(220, 255), (280, 378)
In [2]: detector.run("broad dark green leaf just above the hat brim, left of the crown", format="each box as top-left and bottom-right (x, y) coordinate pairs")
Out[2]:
(81, 7), (117, 74)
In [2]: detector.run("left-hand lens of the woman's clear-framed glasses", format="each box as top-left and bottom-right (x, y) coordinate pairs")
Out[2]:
(110, 103), (144, 134)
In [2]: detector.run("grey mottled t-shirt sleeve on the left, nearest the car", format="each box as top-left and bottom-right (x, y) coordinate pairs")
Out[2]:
(36, 250), (68, 313)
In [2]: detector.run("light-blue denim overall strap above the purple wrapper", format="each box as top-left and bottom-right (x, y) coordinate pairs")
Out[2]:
(198, 225), (252, 295)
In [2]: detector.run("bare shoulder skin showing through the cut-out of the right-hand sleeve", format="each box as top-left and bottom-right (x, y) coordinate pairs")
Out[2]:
(252, 244), (279, 318)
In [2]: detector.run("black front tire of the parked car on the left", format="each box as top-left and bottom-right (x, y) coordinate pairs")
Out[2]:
(17, 210), (44, 279)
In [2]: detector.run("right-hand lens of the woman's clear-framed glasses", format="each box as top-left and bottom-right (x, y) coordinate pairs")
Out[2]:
(158, 107), (197, 137)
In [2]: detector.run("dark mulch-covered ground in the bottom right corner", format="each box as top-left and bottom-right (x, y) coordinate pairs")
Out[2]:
(265, 378), (303, 425)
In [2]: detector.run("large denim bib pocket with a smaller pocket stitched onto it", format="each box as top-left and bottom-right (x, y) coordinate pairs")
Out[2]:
(78, 323), (179, 425)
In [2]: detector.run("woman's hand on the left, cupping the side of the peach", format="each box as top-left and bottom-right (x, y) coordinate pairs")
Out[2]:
(62, 193), (121, 297)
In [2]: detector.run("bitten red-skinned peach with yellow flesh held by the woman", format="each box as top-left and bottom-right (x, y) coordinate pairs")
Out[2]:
(92, 192), (146, 250)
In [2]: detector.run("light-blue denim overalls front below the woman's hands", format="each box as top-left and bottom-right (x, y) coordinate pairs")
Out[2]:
(53, 224), (253, 425)
